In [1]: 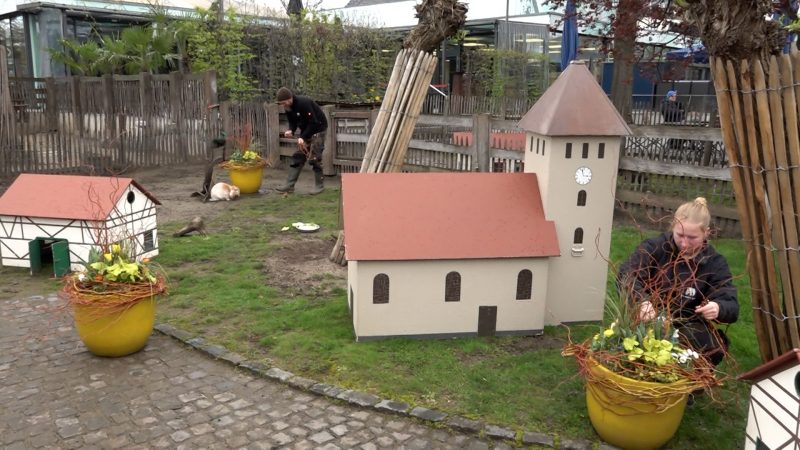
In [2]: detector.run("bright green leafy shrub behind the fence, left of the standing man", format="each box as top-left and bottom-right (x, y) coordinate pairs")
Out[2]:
(177, 8), (256, 100)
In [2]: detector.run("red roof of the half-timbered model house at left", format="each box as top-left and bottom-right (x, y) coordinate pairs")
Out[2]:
(0, 173), (161, 220)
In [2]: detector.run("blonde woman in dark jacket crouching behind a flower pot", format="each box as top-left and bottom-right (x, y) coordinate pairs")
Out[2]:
(618, 197), (739, 365)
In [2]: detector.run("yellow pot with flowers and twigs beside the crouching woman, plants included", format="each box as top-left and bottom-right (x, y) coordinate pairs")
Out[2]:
(562, 290), (720, 450)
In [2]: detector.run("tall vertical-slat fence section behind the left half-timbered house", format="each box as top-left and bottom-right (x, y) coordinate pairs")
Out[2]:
(0, 72), (216, 176)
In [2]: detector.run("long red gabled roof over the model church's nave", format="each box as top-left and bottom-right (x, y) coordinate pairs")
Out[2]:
(342, 173), (560, 261)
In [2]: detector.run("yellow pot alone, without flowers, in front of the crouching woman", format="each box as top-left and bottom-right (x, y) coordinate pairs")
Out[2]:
(586, 362), (688, 450)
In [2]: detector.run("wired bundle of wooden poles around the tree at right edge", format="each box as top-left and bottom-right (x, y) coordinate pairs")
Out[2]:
(712, 52), (800, 361)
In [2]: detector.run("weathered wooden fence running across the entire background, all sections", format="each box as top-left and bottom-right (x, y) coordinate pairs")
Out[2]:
(0, 73), (739, 235)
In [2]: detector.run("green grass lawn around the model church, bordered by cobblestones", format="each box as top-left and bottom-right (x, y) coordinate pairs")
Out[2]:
(0, 185), (760, 449)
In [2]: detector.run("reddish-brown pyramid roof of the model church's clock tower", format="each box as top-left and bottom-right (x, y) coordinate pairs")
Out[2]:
(518, 61), (631, 136)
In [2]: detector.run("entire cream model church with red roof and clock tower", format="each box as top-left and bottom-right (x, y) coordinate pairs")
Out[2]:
(342, 62), (630, 341)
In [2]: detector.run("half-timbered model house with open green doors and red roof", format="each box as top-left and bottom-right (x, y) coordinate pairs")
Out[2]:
(0, 174), (161, 276)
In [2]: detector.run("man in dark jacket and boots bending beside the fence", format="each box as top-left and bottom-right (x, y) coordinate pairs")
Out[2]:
(275, 87), (328, 195)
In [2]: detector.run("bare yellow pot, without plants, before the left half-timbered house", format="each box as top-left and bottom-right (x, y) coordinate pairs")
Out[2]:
(73, 297), (156, 356)
